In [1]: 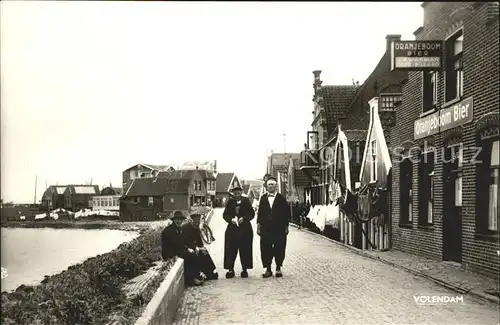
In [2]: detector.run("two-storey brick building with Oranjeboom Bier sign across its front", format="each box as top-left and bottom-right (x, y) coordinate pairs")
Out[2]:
(390, 2), (500, 278)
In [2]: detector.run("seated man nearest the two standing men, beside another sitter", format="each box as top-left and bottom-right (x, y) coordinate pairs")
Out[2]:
(182, 211), (219, 280)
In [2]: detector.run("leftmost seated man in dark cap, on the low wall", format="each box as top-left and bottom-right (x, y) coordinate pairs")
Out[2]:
(161, 211), (203, 285)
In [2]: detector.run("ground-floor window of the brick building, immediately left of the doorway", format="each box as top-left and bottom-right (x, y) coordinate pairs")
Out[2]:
(418, 151), (435, 225)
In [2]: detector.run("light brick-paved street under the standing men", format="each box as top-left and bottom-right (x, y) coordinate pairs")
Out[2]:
(175, 209), (500, 325)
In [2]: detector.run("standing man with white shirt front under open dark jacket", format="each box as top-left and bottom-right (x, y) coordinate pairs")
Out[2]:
(257, 177), (290, 278)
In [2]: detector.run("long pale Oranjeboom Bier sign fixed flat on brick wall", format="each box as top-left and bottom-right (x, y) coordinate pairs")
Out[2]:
(414, 97), (474, 140)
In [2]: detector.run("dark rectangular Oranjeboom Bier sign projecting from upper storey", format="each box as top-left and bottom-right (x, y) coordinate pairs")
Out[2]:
(391, 41), (444, 71)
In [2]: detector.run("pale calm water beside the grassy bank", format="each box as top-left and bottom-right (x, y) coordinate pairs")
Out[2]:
(1, 228), (138, 292)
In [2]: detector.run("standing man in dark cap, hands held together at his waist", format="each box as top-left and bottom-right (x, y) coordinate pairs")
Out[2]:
(222, 187), (255, 279)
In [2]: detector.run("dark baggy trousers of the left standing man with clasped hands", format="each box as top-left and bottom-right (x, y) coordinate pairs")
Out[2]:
(224, 228), (253, 270)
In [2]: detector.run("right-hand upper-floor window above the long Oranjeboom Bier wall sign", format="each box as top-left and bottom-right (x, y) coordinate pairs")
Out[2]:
(445, 31), (464, 102)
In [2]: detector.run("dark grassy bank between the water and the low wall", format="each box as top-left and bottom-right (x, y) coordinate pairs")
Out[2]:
(0, 225), (174, 325)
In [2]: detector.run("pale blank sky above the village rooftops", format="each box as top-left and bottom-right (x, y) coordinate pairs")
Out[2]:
(0, 1), (423, 202)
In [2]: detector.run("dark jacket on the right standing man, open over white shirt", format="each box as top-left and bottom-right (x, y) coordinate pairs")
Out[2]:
(257, 193), (291, 232)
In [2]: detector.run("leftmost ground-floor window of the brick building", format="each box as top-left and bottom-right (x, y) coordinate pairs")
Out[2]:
(399, 158), (413, 224)
